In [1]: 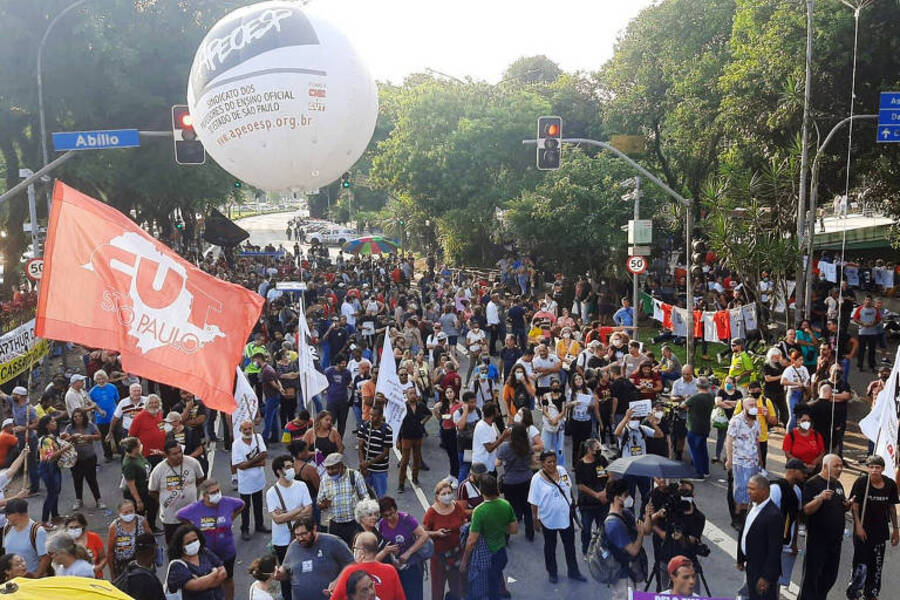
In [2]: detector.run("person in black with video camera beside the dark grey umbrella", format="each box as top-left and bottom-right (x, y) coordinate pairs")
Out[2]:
(653, 481), (710, 592)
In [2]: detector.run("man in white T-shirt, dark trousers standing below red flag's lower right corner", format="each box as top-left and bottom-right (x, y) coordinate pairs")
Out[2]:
(231, 421), (270, 542)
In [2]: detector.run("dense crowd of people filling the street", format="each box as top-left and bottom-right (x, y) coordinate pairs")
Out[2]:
(0, 223), (900, 600)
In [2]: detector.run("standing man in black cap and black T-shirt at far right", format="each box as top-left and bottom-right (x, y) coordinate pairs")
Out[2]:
(847, 455), (900, 600)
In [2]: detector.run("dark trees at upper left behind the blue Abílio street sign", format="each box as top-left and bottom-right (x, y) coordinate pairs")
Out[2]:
(0, 0), (238, 294)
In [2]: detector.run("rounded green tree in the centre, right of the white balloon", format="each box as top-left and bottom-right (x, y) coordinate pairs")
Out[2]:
(371, 77), (549, 264)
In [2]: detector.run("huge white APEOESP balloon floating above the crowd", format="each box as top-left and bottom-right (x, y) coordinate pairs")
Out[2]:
(187, 0), (378, 191)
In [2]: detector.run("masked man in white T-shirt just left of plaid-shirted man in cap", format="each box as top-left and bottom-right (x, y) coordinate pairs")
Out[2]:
(266, 454), (312, 598)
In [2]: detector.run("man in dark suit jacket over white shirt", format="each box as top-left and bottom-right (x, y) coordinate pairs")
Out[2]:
(737, 474), (782, 600)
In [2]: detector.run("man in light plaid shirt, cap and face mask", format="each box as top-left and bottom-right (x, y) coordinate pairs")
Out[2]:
(316, 452), (369, 546)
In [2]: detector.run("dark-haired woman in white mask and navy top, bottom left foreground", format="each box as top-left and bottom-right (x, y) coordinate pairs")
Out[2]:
(163, 525), (228, 600)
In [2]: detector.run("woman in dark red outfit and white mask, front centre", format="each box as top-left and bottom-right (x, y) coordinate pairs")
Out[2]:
(422, 479), (466, 598)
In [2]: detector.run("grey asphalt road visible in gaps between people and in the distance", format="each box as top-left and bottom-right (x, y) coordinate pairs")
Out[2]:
(28, 213), (900, 600)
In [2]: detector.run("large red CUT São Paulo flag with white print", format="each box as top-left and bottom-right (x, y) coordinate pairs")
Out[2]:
(35, 181), (265, 413)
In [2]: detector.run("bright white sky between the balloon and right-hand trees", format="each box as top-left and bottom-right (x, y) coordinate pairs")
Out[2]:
(307, 0), (653, 83)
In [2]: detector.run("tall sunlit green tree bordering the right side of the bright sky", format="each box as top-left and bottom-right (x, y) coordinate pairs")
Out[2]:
(595, 0), (735, 198)
